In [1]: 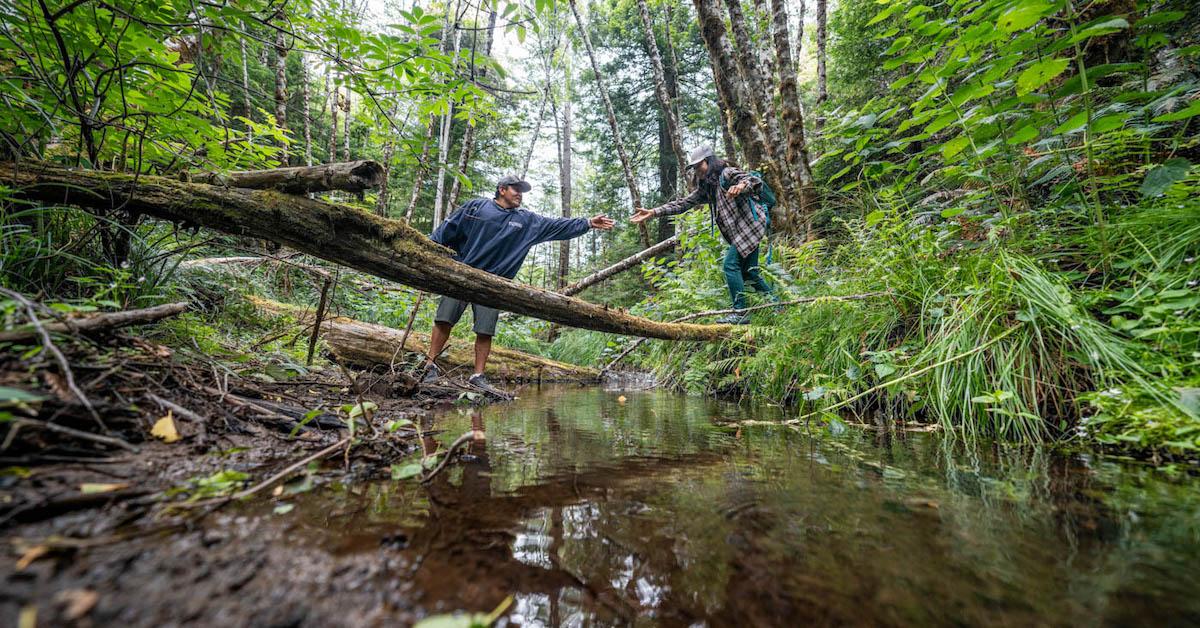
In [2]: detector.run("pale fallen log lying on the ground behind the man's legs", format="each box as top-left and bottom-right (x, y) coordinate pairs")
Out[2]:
(247, 297), (600, 382)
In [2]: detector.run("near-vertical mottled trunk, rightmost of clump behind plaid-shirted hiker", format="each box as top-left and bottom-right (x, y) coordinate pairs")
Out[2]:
(770, 0), (816, 237)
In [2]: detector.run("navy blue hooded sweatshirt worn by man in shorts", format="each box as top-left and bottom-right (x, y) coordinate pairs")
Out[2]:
(430, 198), (592, 279)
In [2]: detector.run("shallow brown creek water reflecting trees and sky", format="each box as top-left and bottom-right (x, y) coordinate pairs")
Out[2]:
(270, 388), (1200, 626)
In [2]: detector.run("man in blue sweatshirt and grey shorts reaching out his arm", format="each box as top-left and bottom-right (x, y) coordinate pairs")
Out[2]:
(422, 175), (613, 395)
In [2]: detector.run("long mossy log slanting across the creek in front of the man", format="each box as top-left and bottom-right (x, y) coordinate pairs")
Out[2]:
(0, 162), (730, 341)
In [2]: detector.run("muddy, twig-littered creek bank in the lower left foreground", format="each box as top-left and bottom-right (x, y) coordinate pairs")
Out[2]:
(0, 329), (501, 626)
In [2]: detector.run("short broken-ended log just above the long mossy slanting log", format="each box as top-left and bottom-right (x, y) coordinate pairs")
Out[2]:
(191, 161), (384, 195)
